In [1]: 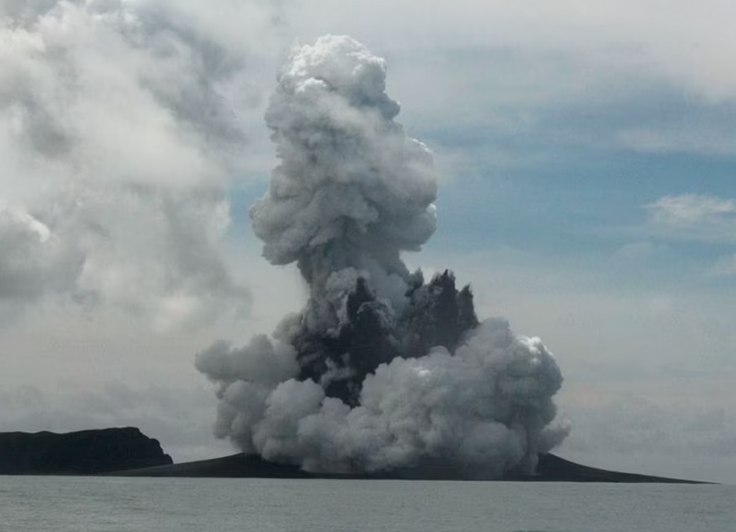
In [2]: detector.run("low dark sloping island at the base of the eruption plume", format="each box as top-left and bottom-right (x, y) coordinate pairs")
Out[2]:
(114, 454), (708, 484)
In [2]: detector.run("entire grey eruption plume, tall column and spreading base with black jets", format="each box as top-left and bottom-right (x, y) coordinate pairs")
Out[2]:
(197, 36), (565, 478)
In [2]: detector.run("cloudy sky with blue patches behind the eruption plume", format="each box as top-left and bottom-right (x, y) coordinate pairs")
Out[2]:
(0, 0), (736, 483)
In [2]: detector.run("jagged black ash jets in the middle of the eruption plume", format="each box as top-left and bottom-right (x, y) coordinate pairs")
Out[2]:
(291, 270), (479, 407)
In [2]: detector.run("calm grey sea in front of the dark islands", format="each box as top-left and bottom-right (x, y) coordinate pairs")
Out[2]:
(0, 477), (736, 532)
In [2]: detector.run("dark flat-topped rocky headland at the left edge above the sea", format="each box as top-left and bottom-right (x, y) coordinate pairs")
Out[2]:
(0, 427), (173, 475)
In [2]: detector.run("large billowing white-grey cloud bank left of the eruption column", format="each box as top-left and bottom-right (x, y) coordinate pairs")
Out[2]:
(0, 0), (282, 326)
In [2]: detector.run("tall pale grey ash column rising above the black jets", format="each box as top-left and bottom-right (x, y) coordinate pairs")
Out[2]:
(250, 35), (437, 318)
